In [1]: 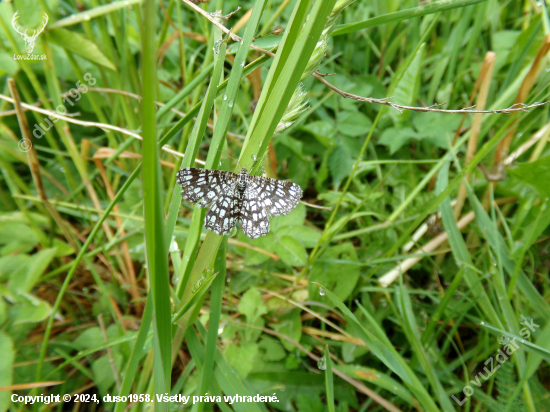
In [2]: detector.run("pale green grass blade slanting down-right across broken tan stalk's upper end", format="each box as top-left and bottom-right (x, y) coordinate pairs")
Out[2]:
(435, 162), (502, 326)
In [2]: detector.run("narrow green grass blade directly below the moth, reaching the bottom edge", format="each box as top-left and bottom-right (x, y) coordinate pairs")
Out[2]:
(192, 237), (227, 412)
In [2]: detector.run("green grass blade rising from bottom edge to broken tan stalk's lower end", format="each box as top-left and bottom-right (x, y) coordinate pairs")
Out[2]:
(395, 275), (455, 412)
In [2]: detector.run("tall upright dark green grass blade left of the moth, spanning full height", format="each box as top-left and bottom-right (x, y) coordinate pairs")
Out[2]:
(141, 0), (172, 402)
